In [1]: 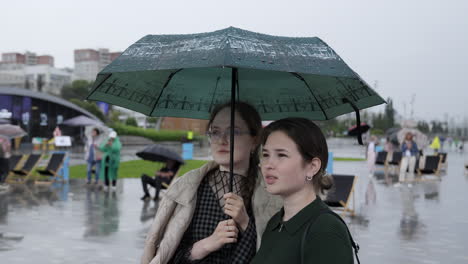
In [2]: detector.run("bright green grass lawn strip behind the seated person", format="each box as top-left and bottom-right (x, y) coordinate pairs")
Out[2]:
(70, 160), (207, 179)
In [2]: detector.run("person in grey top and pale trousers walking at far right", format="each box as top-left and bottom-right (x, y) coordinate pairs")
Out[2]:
(395, 132), (419, 187)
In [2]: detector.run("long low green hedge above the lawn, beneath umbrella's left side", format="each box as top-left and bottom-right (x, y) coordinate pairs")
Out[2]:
(111, 123), (200, 142)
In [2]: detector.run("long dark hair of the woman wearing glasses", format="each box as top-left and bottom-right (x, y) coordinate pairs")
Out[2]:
(207, 101), (262, 209)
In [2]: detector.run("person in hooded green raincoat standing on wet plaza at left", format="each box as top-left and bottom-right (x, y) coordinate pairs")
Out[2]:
(99, 131), (122, 191)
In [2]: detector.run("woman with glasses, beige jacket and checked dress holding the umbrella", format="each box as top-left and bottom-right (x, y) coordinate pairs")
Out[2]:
(141, 102), (281, 264)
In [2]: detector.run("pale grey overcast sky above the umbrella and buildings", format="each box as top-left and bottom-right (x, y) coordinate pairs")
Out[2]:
(0, 0), (468, 120)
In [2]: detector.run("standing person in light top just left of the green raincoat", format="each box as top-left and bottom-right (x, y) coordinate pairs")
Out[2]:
(85, 128), (102, 184)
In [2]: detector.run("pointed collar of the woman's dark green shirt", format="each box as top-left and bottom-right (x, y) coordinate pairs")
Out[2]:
(269, 196), (327, 235)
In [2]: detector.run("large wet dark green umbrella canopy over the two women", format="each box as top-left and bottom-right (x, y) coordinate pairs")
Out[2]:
(88, 27), (385, 120)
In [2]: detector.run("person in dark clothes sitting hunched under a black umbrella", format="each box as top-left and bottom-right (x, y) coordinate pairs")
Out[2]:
(141, 160), (180, 201)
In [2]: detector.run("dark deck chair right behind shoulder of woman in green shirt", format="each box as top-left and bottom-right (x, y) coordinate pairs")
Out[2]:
(325, 174), (357, 216)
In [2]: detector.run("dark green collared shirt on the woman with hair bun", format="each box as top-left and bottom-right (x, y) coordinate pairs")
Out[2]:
(251, 197), (354, 264)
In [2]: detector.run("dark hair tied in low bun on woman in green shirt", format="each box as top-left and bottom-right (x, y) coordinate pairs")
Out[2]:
(261, 117), (333, 194)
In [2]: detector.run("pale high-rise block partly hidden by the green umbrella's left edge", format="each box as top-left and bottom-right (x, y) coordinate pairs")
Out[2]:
(73, 49), (121, 81)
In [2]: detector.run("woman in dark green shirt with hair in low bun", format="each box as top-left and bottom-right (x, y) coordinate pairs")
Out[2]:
(251, 118), (354, 264)
